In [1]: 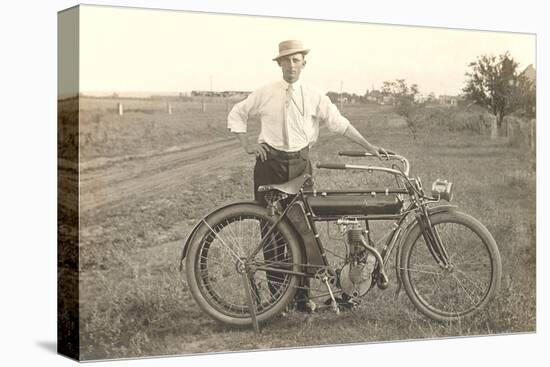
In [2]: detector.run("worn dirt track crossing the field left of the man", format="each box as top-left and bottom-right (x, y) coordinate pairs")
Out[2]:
(80, 139), (244, 212)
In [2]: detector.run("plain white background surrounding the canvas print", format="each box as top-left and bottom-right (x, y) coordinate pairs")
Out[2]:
(0, 0), (550, 366)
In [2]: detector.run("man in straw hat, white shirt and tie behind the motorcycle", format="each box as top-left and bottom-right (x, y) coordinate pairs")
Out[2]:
(227, 40), (387, 310)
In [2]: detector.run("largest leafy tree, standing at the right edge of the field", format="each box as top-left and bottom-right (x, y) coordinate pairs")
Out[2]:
(462, 52), (529, 127)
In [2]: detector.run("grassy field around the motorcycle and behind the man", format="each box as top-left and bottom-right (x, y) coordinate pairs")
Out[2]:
(62, 100), (536, 359)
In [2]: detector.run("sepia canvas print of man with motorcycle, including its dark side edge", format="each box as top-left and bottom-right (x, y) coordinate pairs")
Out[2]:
(57, 5), (537, 361)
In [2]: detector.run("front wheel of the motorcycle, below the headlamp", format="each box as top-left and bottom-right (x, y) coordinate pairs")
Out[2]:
(400, 210), (502, 322)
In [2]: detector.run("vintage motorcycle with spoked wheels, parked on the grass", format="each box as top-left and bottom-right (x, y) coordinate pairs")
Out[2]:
(180, 151), (502, 331)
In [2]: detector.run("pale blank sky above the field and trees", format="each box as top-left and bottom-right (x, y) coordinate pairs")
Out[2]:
(74, 5), (536, 95)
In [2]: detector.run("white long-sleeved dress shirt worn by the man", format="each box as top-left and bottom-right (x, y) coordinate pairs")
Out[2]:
(227, 80), (350, 152)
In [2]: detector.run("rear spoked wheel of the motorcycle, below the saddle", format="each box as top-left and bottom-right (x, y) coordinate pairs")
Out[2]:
(186, 203), (302, 326)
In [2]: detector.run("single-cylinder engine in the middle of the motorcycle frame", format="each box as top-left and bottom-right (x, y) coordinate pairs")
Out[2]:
(339, 221), (376, 297)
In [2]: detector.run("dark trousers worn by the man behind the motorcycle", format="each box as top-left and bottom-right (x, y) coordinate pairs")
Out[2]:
(254, 148), (312, 302)
